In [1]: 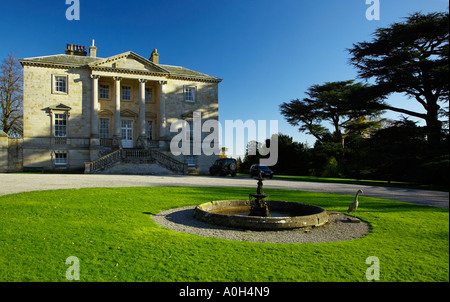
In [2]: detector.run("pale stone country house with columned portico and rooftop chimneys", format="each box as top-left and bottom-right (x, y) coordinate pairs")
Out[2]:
(19, 44), (221, 174)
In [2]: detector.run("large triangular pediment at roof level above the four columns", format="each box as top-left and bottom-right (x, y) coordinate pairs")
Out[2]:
(89, 51), (169, 74)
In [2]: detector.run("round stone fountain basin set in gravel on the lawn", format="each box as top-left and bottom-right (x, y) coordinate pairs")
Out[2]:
(194, 200), (328, 231)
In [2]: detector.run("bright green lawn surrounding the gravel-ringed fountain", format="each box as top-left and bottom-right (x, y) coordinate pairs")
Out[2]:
(0, 187), (449, 282)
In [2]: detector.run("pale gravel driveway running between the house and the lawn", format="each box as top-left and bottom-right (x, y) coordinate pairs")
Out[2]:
(0, 173), (449, 209)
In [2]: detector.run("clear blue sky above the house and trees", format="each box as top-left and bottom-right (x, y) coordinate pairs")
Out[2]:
(0, 0), (448, 157)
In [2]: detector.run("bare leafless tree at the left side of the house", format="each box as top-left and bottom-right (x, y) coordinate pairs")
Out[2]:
(0, 53), (23, 137)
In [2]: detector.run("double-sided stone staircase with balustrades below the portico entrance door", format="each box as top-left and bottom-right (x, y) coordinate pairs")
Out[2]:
(84, 149), (188, 175)
